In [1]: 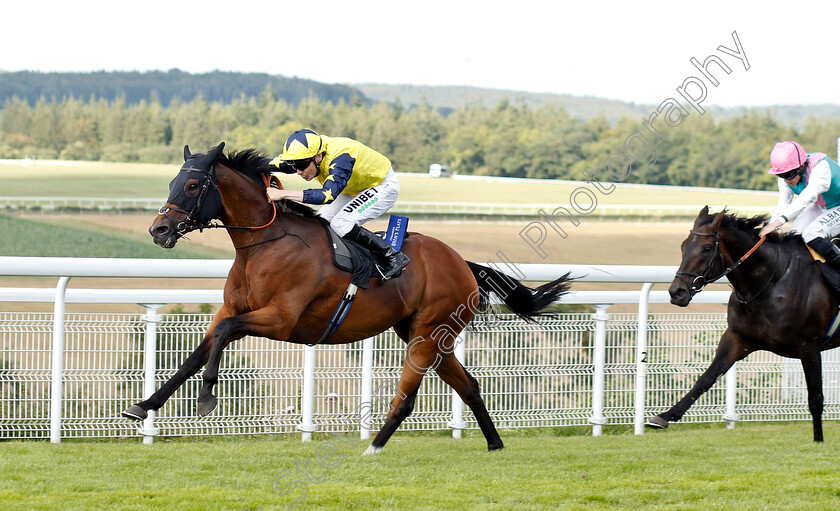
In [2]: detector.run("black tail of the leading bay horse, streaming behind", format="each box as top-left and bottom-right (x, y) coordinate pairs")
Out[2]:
(467, 261), (574, 322)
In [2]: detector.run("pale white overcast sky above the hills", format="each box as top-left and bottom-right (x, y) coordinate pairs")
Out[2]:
(6, 0), (840, 106)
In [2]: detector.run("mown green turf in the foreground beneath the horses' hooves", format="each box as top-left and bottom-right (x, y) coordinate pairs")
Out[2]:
(0, 423), (840, 510)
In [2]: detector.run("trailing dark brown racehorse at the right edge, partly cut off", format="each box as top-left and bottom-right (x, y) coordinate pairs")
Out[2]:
(647, 206), (840, 442)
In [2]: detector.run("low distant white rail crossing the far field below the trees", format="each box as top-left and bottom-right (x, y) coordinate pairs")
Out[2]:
(0, 197), (768, 218)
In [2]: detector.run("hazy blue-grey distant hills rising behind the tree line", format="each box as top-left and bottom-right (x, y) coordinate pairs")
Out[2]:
(0, 69), (840, 126)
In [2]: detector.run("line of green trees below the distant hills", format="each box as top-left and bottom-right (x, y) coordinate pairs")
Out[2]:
(0, 88), (840, 189)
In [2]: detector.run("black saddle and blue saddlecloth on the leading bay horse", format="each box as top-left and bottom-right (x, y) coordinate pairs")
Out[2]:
(318, 215), (408, 289)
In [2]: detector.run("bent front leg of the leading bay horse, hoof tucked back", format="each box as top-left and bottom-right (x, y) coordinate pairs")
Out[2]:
(198, 307), (295, 417)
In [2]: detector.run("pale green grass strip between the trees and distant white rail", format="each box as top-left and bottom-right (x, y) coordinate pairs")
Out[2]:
(0, 161), (777, 207)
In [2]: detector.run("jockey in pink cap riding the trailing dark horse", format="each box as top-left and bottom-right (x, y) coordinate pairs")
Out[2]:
(759, 140), (840, 270)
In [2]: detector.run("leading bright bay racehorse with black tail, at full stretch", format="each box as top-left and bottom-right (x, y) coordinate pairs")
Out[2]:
(123, 144), (570, 454)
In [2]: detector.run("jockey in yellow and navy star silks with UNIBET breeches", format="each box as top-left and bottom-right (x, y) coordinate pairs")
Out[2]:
(266, 129), (409, 280)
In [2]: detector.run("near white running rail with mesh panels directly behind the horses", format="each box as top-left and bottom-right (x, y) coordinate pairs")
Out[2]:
(0, 257), (840, 443)
